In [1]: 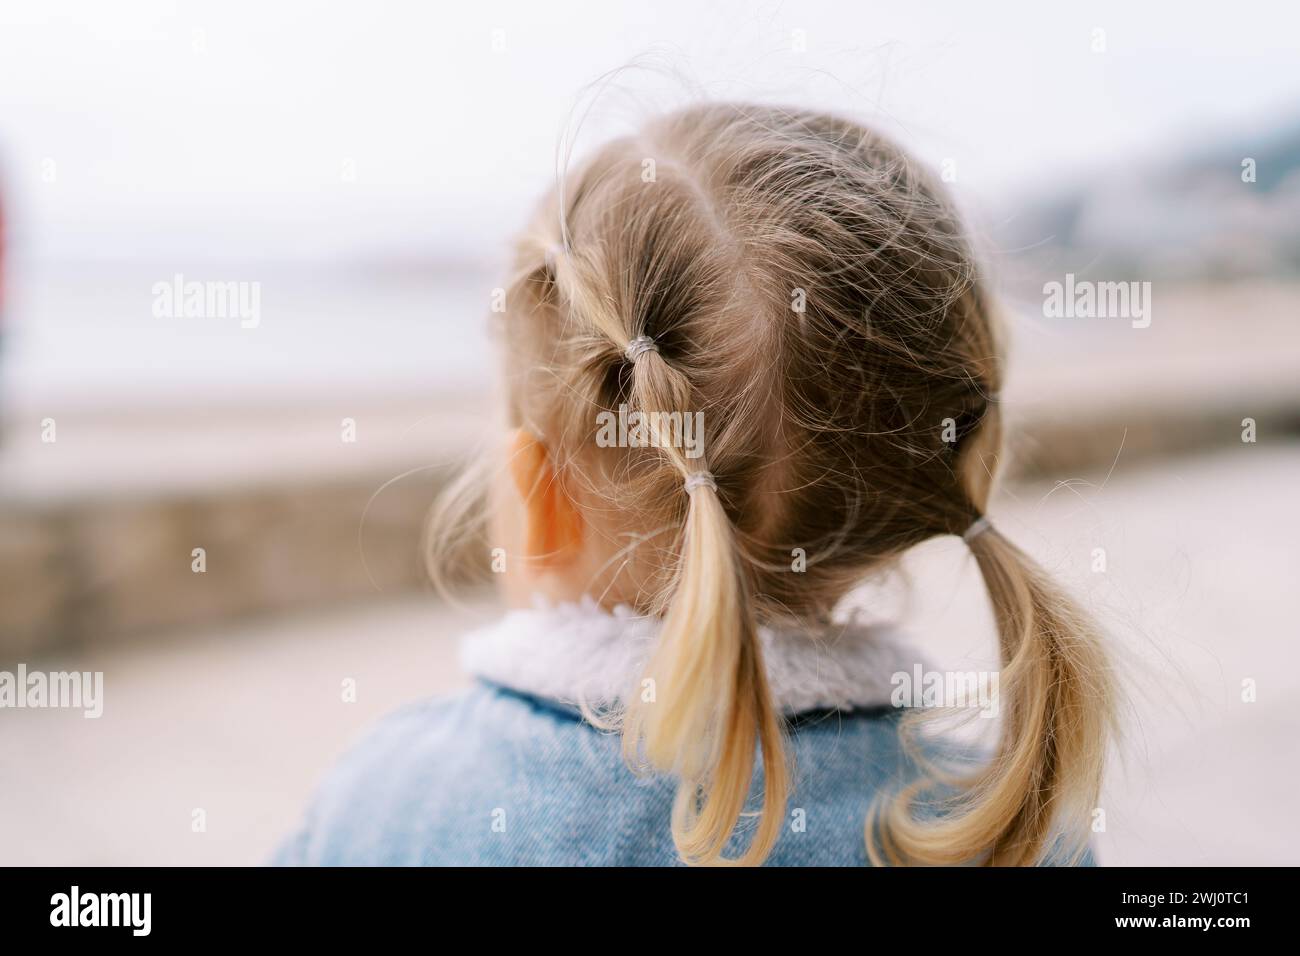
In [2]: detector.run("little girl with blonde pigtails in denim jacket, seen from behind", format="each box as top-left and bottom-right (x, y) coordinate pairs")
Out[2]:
(280, 104), (1112, 865)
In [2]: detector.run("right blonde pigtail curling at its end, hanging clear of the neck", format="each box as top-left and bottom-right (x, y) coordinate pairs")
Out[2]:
(867, 519), (1112, 866)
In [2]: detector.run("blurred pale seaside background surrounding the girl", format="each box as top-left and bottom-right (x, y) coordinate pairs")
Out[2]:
(0, 0), (1300, 864)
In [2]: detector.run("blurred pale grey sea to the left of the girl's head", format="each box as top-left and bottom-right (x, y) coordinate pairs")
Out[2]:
(0, 263), (499, 412)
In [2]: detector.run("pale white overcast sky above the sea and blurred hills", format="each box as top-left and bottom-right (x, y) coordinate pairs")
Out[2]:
(0, 0), (1300, 261)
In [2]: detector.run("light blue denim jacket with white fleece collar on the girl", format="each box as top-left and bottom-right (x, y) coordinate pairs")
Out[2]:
(274, 602), (1097, 866)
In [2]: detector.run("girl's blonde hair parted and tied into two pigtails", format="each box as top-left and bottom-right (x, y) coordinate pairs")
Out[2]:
(433, 104), (1110, 864)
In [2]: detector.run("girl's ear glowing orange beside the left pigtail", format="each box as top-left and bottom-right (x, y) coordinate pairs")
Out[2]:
(510, 428), (582, 568)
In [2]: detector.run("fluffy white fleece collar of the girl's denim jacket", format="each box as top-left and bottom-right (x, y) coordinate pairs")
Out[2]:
(460, 598), (922, 714)
